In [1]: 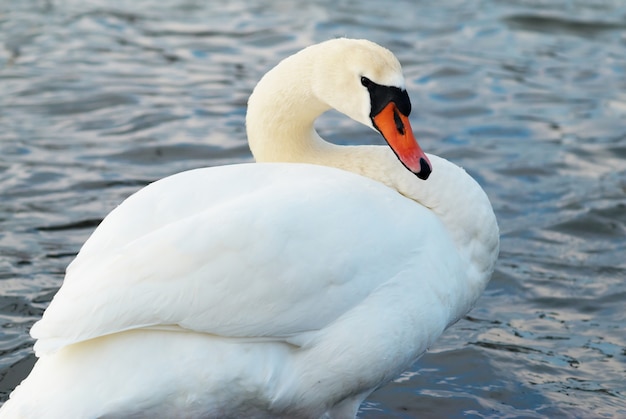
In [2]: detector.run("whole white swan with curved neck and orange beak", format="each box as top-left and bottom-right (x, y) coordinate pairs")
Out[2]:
(0, 39), (498, 419)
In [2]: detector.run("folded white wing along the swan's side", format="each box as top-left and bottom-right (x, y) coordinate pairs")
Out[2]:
(31, 165), (448, 352)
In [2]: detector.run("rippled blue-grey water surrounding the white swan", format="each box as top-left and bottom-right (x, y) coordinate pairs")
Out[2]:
(0, 0), (626, 418)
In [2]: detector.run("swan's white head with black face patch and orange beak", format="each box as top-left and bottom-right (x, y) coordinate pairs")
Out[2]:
(311, 39), (432, 179)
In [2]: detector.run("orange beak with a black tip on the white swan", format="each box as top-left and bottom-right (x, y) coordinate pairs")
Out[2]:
(372, 102), (432, 180)
